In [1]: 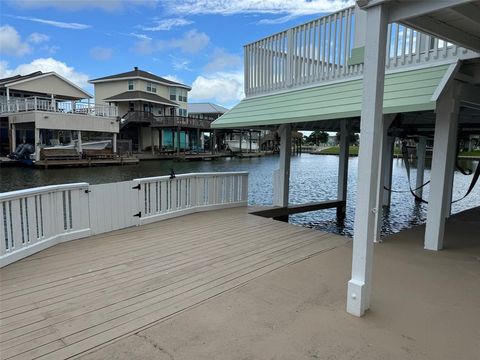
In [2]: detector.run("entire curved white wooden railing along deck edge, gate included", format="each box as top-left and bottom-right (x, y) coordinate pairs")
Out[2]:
(0, 172), (248, 267)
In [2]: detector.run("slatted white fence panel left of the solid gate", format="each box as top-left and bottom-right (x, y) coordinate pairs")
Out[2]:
(0, 183), (90, 267)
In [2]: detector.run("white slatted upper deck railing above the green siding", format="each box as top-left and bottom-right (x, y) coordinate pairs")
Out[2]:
(244, 6), (475, 97)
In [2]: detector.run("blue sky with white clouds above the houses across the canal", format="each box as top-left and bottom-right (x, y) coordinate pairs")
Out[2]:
(0, 0), (352, 107)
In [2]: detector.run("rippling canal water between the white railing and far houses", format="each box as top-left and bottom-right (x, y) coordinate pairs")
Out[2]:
(0, 154), (480, 235)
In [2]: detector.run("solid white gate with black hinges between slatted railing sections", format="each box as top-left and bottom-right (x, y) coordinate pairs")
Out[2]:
(88, 181), (139, 235)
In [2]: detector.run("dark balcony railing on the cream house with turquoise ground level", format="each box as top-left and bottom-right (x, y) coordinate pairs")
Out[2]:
(121, 111), (211, 129)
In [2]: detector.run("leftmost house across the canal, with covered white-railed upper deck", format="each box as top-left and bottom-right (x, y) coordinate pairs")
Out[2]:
(0, 71), (119, 161)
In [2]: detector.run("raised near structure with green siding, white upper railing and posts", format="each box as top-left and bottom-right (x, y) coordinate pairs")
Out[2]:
(212, 0), (480, 316)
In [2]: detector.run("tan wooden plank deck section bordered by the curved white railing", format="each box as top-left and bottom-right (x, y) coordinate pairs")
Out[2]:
(0, 208), (349, 359)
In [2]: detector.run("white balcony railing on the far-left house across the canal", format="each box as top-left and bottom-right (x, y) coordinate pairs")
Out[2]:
(0, 96), (118, 117)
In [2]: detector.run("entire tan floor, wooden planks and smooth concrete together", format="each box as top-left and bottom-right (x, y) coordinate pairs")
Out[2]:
(0, 208), (480, 360)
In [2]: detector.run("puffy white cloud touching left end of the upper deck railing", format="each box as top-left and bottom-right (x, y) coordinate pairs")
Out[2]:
(188, 71), (244, 106)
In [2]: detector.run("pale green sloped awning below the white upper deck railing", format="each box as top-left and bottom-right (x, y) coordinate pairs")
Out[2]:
(212, 64), (455, 129)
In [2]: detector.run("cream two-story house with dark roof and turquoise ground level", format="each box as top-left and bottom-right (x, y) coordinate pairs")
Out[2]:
(90, 67), (210, 153)
